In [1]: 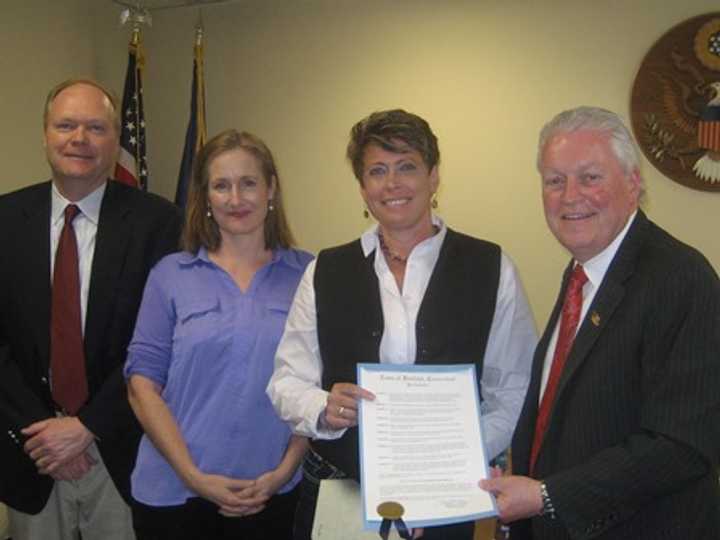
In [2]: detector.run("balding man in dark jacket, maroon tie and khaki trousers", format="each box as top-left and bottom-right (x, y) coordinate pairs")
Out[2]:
(0, 80), (181, 540)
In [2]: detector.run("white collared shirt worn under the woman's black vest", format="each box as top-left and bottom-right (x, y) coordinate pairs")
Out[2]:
(267, 216), (537, 457)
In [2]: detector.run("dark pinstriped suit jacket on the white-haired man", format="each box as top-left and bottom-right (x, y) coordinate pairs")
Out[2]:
(512, 211), (720, 540)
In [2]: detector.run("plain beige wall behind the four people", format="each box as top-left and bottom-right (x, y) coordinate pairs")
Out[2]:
(0, 0), (720, 326)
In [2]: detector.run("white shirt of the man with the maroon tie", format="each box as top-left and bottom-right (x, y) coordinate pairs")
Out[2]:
(50, 182), (107, 333)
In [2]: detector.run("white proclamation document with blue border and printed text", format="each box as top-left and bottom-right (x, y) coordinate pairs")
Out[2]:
(358, 364), (497, 529)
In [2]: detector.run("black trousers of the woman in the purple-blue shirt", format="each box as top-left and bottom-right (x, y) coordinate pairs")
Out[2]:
(132, 487), (299, 540)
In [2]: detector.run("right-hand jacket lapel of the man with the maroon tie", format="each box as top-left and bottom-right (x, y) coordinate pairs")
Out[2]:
(85, 181), (131, 363)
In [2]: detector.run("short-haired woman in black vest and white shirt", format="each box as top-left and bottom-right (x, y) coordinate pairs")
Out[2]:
(268, 110), (536, 540)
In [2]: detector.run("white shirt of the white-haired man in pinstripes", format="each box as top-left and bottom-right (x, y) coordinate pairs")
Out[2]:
(538, 210), (637, 402)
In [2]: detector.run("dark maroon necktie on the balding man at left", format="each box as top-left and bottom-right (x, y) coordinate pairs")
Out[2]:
(50, 204), (88, 415)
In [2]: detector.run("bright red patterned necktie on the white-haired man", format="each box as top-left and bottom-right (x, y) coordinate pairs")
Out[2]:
(530, 264), (587, 472)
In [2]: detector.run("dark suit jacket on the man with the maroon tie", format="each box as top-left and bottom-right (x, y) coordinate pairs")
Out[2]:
(0, 182), (181, 513)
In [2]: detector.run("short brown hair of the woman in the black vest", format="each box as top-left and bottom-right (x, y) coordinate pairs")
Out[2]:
(347, 109), (440, 184)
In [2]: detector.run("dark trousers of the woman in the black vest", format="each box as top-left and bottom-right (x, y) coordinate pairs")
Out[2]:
(292, 449), (475, 540)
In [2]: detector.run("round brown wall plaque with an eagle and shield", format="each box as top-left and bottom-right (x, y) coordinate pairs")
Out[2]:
(630, 13), (720, 191)
